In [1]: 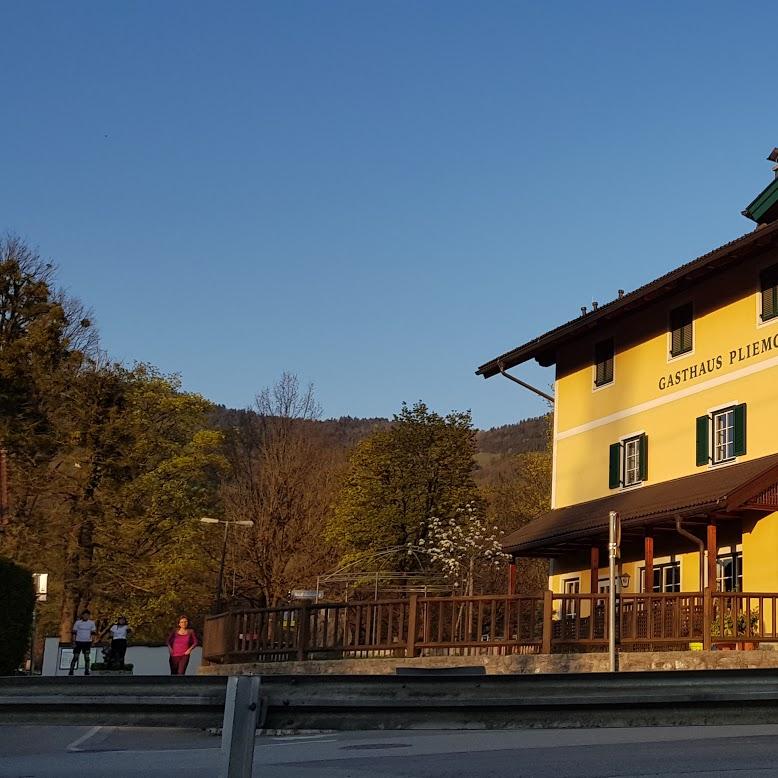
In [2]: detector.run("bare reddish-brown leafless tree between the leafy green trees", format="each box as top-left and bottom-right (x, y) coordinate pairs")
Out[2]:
(222, 373), (341, 606)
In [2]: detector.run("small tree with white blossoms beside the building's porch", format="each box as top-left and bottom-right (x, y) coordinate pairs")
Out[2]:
(416, 503), (510, 596)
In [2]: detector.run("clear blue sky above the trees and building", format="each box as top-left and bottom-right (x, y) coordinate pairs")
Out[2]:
(0, 0), (778, 427)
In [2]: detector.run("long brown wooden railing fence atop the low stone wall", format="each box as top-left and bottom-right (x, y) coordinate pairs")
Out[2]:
(203, 590), (778, 662)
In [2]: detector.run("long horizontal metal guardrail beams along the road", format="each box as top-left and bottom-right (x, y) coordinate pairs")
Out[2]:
(6, 670), (778, 730)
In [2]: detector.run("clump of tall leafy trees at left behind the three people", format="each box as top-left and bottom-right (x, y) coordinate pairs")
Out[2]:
(0, 238), (223, 639)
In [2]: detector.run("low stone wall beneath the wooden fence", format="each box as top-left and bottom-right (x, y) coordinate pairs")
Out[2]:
(198, 649), (778, 675)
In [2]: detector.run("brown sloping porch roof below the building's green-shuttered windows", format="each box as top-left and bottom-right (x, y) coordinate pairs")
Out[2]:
(502, 454), (778, 556)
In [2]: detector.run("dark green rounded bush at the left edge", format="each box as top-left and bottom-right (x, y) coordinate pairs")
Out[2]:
(0, 557), (35, 675)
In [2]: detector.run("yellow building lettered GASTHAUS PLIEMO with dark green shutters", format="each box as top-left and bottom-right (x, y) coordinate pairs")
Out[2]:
(478, 150), (778, 594)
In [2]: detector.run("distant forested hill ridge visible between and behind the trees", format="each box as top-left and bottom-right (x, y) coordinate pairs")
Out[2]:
(213, 406), (546, 454)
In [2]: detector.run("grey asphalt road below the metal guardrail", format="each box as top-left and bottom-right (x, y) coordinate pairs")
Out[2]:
(0, 725), (778, 778)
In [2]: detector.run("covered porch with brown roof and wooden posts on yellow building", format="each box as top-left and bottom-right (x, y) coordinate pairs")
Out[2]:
(503, 455), (778, 650)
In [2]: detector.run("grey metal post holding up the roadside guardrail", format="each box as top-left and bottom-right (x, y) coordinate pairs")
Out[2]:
(219, 675), (260, 778)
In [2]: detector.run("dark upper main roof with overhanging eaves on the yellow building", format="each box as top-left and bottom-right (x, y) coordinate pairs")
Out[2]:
(476, 221), (778, 378)
